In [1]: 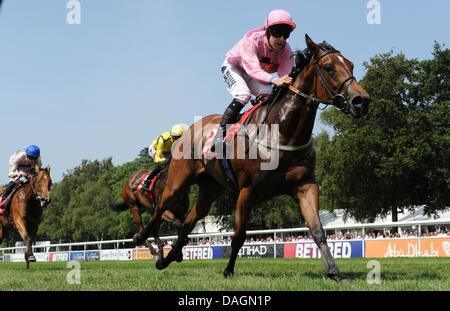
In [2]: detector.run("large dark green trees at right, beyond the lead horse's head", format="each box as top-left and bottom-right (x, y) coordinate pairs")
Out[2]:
(317, 44), (450, 221)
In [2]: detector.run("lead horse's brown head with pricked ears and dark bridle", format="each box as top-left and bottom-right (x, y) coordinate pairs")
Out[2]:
(298, 35), (369, 118)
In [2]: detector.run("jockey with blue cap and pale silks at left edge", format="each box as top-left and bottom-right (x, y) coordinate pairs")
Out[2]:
(0, 145), (42, 201)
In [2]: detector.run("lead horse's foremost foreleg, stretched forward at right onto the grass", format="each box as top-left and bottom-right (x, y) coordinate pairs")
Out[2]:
(294, 182), (343, 281)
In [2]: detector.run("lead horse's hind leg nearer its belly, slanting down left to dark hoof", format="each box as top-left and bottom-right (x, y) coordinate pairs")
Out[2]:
(156, 176), (223, 270)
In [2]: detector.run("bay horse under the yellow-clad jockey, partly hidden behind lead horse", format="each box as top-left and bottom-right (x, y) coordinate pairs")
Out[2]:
(110, 169), (189, 255)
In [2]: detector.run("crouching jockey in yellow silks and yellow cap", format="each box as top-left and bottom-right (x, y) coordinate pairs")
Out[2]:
(142, 124), (186, 191)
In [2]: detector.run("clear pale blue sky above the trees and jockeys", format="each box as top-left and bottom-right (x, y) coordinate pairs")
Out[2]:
(0, 0), (450, 183)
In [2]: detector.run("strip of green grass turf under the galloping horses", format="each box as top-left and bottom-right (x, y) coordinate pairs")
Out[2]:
(0, 258), (450, 291)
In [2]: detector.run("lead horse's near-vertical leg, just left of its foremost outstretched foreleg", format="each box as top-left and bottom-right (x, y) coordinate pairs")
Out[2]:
(223, 188), (252, 277)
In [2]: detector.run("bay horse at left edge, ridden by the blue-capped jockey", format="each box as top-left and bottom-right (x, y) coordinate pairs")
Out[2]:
(0, 165), (52, 269)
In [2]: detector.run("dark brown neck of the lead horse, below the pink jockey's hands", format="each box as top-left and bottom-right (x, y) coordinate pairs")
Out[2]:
(269, 68), (317, 146)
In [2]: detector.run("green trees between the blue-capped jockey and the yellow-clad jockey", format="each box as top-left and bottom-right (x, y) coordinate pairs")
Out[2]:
(39, 156), (155, 242)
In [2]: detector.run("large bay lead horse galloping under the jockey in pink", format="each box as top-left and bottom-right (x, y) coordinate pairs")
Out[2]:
(135, 35), (369, 280)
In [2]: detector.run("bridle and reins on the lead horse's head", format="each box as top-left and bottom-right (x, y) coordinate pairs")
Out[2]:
(288, 50), (356, 112)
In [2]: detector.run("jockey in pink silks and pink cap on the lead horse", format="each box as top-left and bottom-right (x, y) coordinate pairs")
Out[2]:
(211, 9), (304, 151)
